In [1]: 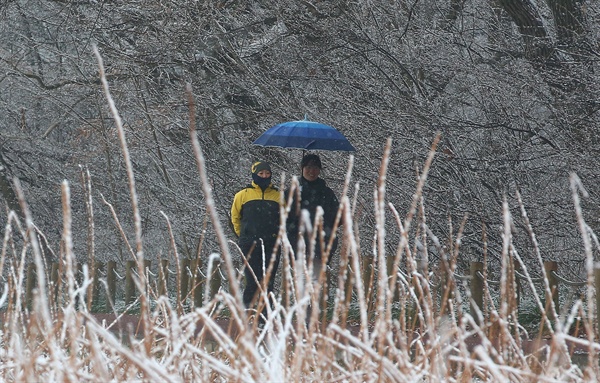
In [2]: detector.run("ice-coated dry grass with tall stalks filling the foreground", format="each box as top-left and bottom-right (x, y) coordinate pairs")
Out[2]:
(0, 73), (600, 382)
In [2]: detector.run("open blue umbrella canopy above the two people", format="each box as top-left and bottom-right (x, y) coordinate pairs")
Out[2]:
(253, 120), (356, 152)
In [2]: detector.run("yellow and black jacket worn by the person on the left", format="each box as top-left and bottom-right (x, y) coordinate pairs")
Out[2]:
(231, 182), (279, 242)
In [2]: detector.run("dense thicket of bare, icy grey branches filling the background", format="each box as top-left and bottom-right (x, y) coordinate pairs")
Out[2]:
(0, 0), (600, 276)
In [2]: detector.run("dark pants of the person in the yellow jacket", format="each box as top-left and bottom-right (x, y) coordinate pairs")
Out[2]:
(240, 240), (280, 307)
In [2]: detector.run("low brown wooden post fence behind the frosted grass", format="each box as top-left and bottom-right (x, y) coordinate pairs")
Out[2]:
(18, 257), (600, 331)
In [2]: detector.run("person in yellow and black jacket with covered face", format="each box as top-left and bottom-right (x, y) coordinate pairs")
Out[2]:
(231, 161), (280, 307)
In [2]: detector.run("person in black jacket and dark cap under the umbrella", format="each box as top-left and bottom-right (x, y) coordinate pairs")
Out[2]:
(286, 154), (339, 269)
